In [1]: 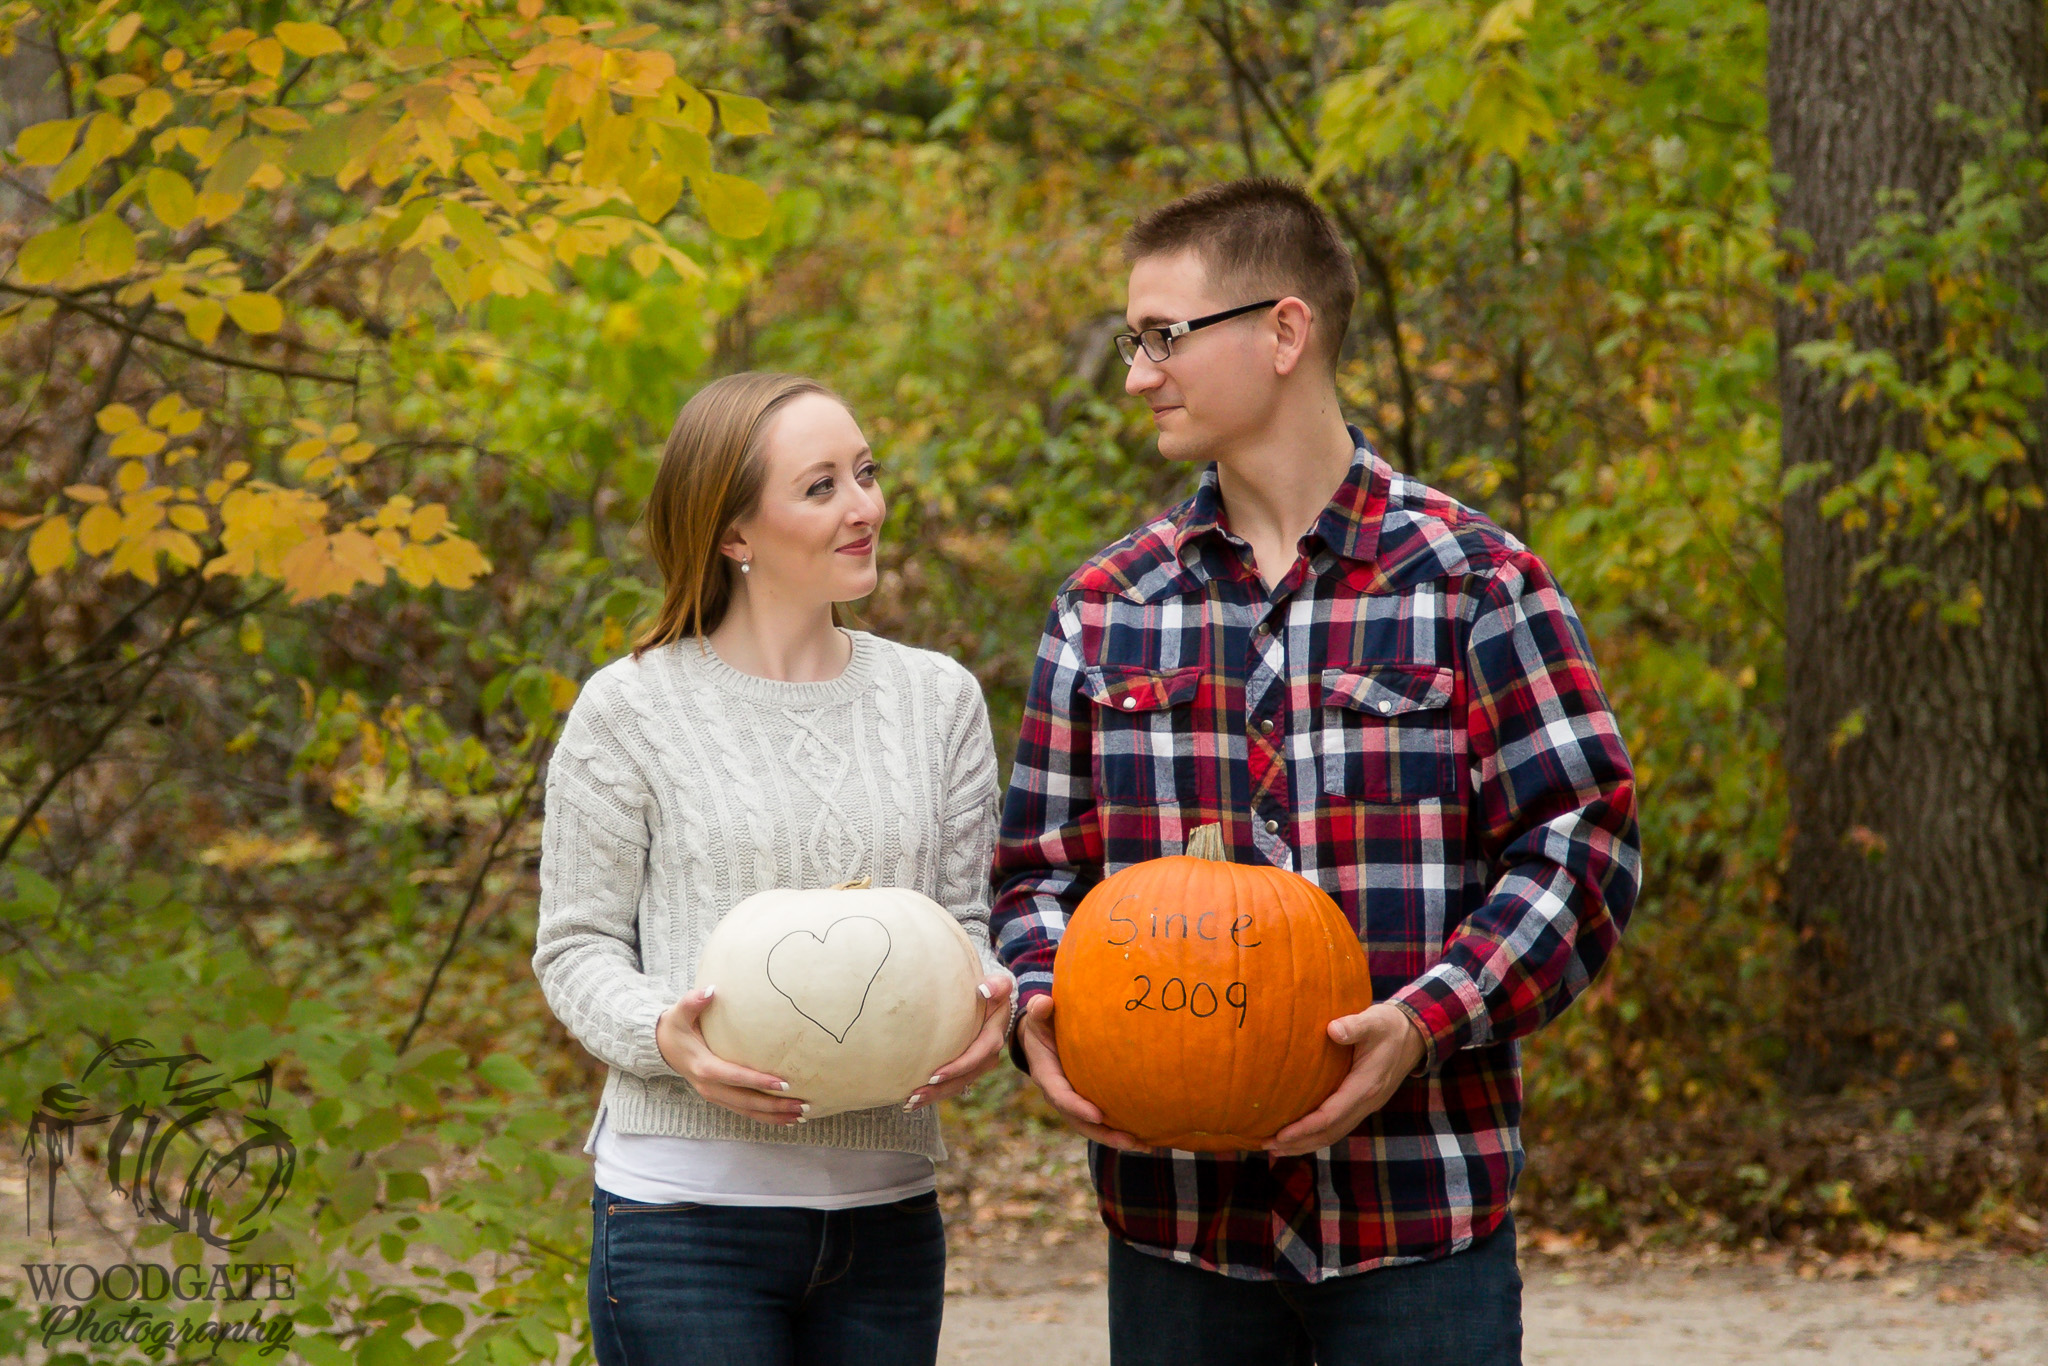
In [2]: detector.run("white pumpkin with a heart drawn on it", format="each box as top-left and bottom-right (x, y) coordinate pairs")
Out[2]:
(696, 879), (983, 1120)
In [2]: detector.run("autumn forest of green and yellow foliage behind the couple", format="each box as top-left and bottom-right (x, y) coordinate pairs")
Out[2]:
(0, 0), (2048, 1366)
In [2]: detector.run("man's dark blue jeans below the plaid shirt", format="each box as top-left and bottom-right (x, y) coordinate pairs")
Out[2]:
(1110, 1214), (1522, 1366)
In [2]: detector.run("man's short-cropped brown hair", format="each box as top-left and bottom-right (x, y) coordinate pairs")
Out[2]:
(1124, 176), (1358, 371)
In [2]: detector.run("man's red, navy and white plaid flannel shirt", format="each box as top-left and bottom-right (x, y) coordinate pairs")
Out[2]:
(991, 426), (1640, 1282)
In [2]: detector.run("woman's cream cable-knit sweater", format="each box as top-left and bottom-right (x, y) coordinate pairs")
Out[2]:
(532, 631), (1004, 1159)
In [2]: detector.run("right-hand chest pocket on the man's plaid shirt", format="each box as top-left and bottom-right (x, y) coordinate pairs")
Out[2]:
(1321, 664), (1458, 803)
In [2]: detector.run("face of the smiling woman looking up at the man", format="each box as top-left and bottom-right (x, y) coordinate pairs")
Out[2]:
(725, 393), (887, 604)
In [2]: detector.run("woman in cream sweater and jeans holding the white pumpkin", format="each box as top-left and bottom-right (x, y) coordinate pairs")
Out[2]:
(532, 373), (1016, 1366)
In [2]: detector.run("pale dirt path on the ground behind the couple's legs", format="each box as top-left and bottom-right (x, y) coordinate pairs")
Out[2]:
(940, 1249), (2048, 1366)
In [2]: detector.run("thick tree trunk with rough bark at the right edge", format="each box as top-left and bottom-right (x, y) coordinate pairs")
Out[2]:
(1769, 0), (2048, 1085)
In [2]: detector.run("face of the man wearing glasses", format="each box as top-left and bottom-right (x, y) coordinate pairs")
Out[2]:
(1124, 250), (1280, 463)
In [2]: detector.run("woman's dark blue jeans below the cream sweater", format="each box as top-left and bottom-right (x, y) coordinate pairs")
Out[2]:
(590, 1186), (946, 1366)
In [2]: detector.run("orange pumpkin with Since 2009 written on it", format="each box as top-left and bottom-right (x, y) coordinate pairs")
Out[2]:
(1053, 825), (1372, 1151)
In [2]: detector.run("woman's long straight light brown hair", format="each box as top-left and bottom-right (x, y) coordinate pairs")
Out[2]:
(633, 371), (846, 659)
